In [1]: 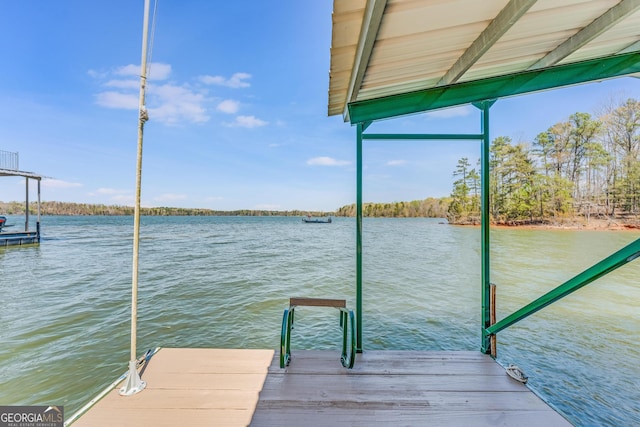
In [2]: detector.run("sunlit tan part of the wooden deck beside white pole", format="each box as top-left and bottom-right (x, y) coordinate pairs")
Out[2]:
(73, 348), (274, 427)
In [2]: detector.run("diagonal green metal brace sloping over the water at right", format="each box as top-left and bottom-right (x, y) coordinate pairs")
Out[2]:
(485, 239), (640, 334)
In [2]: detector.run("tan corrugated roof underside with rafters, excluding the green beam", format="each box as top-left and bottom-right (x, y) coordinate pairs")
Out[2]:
(329, 0), (640, 119)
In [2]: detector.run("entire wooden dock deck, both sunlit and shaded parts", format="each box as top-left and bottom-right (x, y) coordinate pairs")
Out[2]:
(73, 348), (571, 427)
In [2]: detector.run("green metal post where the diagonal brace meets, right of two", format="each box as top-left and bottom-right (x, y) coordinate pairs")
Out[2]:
(473, 100), (496, 354)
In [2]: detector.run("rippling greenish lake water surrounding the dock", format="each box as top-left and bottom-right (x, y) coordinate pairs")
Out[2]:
(0, 217), (640, 426)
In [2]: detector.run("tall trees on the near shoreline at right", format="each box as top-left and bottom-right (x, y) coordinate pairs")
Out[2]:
(448, 98), (640, 223)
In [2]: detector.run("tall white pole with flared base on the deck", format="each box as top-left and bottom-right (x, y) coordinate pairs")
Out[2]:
(120, 0), (149, 396)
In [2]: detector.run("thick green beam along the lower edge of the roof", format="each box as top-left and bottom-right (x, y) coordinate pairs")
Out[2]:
(349, 51), (640, 124)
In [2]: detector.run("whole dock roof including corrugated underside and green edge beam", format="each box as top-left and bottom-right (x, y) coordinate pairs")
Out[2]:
(328, 0), (640, 123)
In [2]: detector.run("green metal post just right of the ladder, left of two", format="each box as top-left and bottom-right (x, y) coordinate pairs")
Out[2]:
(356, 123), (367, 353)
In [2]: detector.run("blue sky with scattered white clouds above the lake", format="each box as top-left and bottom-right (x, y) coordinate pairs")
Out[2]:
(0, 0), (640, 211)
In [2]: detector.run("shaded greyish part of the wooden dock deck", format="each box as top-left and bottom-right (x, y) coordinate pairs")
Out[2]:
(251, 351), (570, 427)
